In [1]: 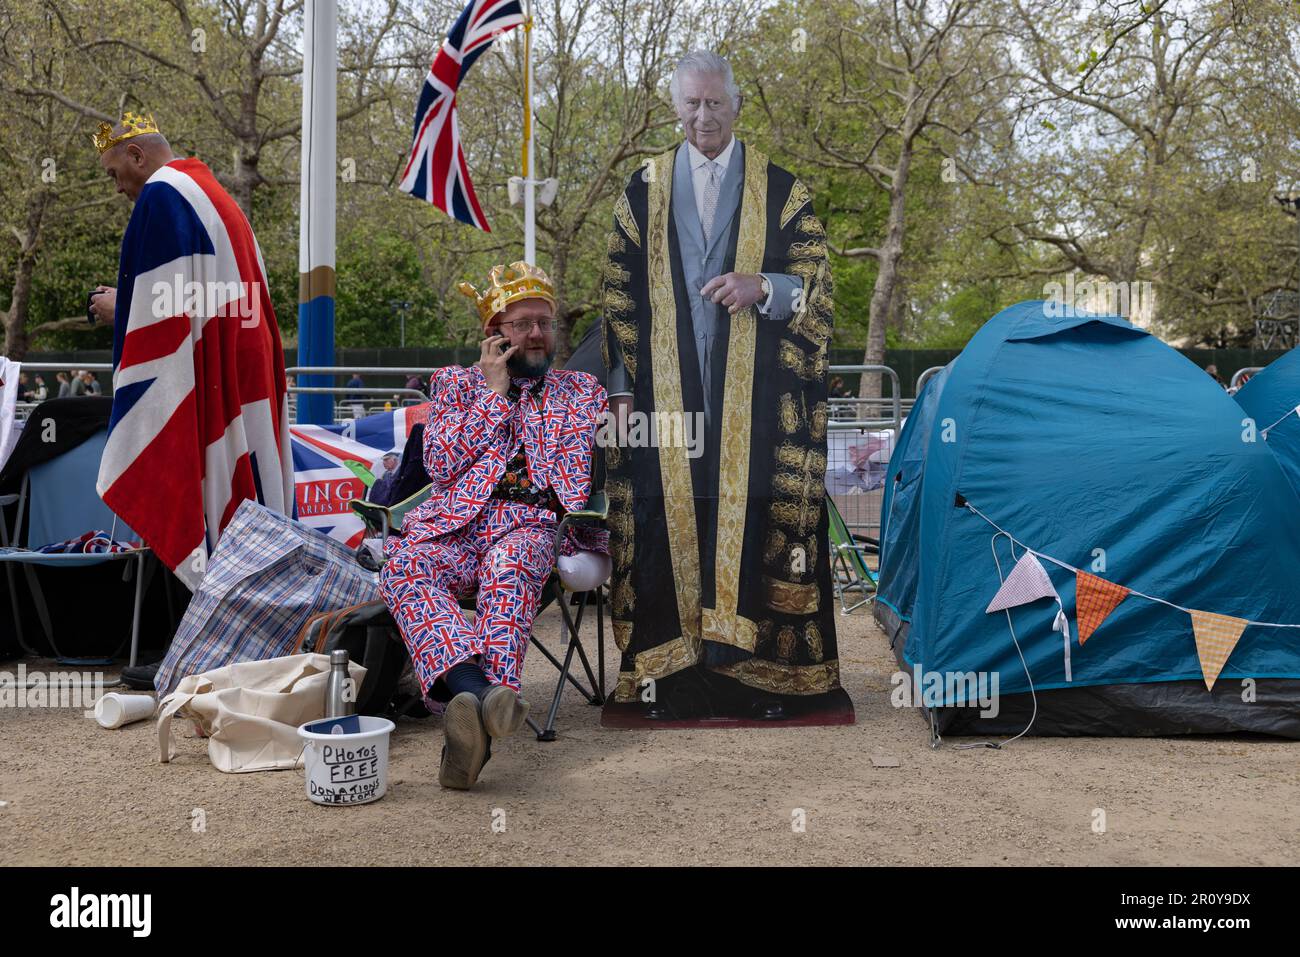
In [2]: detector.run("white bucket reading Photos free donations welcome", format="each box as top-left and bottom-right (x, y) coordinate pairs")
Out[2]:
(298, 714), (397, 805)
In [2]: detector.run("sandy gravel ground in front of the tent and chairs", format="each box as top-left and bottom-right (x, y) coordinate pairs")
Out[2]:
(0, 600), (1300, 865)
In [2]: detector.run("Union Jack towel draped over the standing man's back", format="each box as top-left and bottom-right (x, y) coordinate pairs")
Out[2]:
(96, 159), (294, 590)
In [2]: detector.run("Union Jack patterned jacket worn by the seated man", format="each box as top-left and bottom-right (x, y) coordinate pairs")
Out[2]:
(404, 365), (608, 551)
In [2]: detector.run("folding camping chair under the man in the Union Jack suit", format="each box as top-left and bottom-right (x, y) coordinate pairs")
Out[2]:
(352, 485), (610, 741)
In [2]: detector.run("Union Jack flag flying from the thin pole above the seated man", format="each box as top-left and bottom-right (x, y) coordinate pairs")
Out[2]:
(398, 0), (524, 233)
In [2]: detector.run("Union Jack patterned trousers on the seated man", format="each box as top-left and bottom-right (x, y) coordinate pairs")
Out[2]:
(380, 499), (555, 694)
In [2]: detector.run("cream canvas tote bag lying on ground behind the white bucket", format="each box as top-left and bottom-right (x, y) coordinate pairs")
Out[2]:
(159, 654), (365, 772)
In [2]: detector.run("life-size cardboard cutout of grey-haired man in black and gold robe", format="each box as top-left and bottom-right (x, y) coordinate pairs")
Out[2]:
(605, 51), (842, 720)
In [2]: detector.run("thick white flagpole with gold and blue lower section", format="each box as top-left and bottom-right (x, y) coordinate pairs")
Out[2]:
(298, 0), (338, 425)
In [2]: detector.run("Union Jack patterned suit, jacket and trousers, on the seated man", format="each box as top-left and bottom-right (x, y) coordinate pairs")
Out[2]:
(380, 365), (608, 693)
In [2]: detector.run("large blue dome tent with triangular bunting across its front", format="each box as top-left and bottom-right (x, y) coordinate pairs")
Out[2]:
(875, 302), (1300, 737)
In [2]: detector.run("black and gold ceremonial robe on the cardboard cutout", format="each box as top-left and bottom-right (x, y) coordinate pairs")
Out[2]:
(603, 146), (840, 701)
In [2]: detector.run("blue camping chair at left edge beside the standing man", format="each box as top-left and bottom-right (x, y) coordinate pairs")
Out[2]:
(0, 430), (153, 666)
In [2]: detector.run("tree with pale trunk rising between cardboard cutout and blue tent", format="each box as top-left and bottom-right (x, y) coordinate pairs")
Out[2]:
(761, 0), (1010, 398)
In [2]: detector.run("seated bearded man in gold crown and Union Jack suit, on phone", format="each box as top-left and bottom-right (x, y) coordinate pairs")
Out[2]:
(380, 263), (610, 789)
